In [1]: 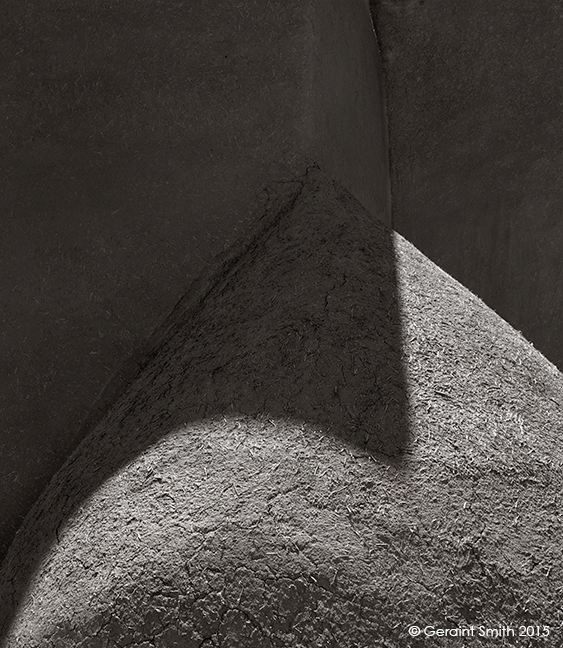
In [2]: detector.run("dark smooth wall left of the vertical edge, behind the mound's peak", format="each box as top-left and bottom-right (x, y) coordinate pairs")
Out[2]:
(0, 0), (390, 557)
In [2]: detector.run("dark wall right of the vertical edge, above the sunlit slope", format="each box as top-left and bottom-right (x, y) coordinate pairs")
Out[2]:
(371, 0), (563, 368)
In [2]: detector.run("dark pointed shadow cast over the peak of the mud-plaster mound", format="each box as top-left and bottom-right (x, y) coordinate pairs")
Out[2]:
(0, 168), (410, 643)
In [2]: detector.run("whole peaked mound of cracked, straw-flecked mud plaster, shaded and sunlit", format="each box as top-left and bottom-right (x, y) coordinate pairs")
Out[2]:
(0, 169), (563, 648)
